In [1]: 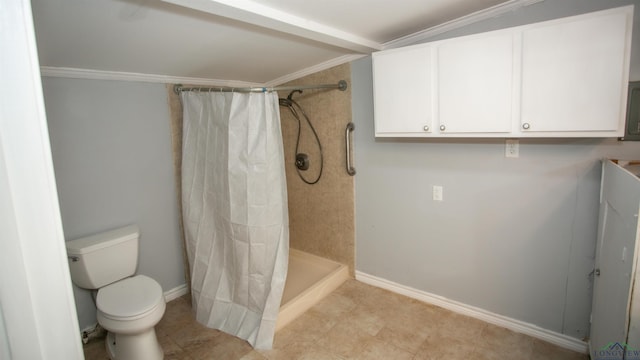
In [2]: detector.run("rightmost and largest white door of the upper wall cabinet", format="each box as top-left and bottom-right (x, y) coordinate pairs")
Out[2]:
(520, 11), (629, 136)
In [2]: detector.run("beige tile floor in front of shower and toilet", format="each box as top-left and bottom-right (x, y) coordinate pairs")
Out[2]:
(84, 280), (589, 360)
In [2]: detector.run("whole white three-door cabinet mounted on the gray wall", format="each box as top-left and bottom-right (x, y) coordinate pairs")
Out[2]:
(373, 6), (633, 138)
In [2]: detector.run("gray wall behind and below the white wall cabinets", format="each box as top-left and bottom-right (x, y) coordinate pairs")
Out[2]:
(352, 0), (640, 338)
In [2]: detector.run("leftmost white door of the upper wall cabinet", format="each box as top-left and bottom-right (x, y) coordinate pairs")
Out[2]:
(373, 46), (433, 136)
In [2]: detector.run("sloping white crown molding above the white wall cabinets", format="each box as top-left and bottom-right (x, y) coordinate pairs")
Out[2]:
(382, 0), (545, 49)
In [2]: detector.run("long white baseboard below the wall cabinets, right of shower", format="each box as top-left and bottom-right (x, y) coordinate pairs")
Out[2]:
(356, 271), (588, 354)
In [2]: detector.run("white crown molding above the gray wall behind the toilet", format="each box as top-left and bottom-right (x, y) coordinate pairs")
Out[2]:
(40, 66), (263, 87)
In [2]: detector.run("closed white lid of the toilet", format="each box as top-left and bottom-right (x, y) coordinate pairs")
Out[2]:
(96, 275), (164, 317)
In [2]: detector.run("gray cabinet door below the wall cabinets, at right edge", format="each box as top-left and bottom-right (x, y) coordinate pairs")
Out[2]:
(589, 161), (640, 359)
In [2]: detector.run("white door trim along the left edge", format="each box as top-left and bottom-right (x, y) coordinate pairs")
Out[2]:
(0, 0), (84, 360)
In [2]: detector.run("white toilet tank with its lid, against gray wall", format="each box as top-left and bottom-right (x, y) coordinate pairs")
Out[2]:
(66, 225), (140, 289)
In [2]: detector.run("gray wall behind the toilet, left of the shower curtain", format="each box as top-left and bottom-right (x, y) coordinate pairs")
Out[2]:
(43, 77), (185, 329)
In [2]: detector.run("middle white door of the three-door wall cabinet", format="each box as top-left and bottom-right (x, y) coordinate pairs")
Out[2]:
(437, 31), (513, 134)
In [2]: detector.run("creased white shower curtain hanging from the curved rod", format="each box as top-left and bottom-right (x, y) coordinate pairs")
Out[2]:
(182, 91), (289, 349)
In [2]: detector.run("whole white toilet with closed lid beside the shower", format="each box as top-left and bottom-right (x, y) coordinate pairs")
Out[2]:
(66, 225), (166, 360)
